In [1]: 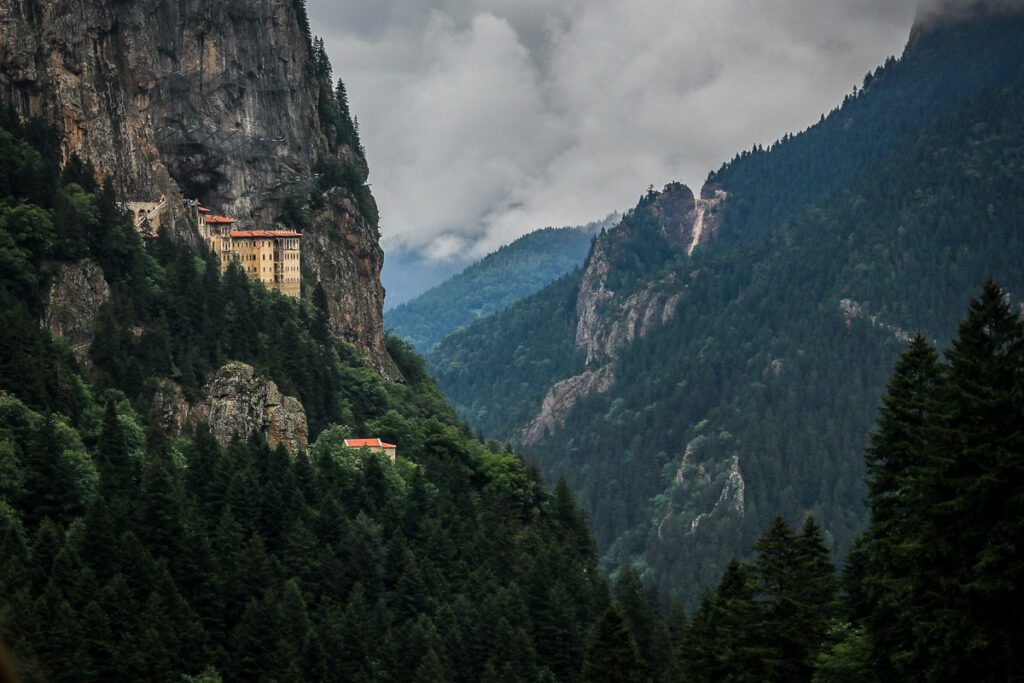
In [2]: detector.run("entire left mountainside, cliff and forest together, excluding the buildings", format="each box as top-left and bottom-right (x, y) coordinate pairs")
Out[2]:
(0, 0), (626, 683)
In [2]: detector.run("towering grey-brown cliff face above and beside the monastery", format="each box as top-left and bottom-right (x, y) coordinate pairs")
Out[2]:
(0, 0), (398, 379)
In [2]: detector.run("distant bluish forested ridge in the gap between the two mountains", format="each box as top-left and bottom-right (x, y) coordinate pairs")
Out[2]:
(384, 215), (617, 352)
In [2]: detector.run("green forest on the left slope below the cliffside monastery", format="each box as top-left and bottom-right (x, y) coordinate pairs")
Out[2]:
(0, 117), (622, 681)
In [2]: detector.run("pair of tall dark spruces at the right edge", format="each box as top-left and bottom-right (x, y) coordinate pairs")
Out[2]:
(856, 282), (1024, 681)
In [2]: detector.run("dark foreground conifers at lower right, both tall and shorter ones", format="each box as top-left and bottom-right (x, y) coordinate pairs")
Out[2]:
(681, 283), (1024, 683)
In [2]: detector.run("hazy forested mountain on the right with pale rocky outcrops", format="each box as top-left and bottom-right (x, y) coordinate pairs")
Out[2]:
(429, 7), (1024, 600)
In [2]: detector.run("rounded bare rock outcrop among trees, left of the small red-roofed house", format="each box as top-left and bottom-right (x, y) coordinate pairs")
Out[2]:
(190, 362), (309, 453)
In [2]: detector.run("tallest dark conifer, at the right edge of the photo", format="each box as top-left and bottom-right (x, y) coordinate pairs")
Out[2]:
(911, 281), (1024, 680)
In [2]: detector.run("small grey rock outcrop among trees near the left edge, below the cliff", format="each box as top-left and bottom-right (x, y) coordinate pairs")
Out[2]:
(43, 259), (111, 366)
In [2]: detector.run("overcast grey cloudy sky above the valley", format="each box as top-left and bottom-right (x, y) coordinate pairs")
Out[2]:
(308, 0), (916, 260)
